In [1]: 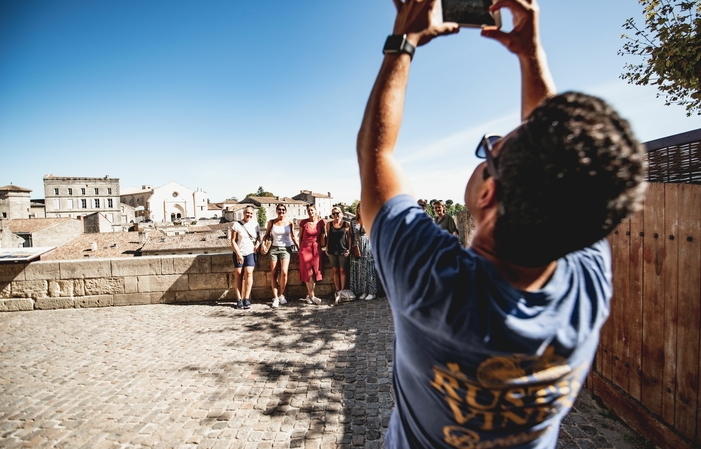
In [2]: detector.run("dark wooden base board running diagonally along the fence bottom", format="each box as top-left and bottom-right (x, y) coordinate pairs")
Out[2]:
(592, 374), (696, 449)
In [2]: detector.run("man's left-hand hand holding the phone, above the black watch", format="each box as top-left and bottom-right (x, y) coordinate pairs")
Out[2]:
(393, 0), (460, 46)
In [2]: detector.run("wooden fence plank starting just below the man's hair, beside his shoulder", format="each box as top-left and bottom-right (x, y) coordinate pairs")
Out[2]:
(609, 216), (630, 392)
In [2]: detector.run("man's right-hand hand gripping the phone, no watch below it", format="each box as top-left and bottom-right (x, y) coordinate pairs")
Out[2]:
(482, 0), (540, 57)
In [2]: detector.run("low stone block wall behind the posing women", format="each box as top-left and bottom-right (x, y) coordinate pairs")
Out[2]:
(0, 254), (333, 312)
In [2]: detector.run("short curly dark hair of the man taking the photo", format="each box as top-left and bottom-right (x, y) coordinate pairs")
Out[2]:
(494, 92), (646, 267)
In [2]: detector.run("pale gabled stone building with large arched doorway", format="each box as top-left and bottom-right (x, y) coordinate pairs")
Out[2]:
(121, 181), (209, 223)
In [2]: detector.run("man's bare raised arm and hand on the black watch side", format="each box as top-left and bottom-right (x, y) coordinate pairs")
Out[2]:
(357, 0), (459, 233)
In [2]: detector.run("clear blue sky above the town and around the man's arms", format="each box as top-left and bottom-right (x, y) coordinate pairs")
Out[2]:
(0, 0), (701, 202)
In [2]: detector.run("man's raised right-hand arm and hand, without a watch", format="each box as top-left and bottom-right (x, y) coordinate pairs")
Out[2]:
(482, 0), (557, 120)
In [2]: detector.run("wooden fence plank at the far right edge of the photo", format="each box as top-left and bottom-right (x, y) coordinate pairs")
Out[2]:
(675, 184), (701, 442)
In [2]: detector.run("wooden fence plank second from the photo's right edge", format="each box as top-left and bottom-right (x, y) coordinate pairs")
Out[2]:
(653, 184), (680, 424)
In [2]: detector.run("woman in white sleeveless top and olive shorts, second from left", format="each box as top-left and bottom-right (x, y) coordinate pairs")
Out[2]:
(263, 203), (299, 309)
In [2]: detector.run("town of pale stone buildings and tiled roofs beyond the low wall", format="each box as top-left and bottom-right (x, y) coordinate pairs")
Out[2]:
(0, 174), (334, 260)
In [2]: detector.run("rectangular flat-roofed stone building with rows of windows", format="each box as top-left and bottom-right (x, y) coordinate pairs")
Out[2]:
(44, 175), (122, 225)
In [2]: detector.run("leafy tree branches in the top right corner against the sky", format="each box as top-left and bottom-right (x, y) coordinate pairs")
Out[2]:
(618, 0), (701, 116)
